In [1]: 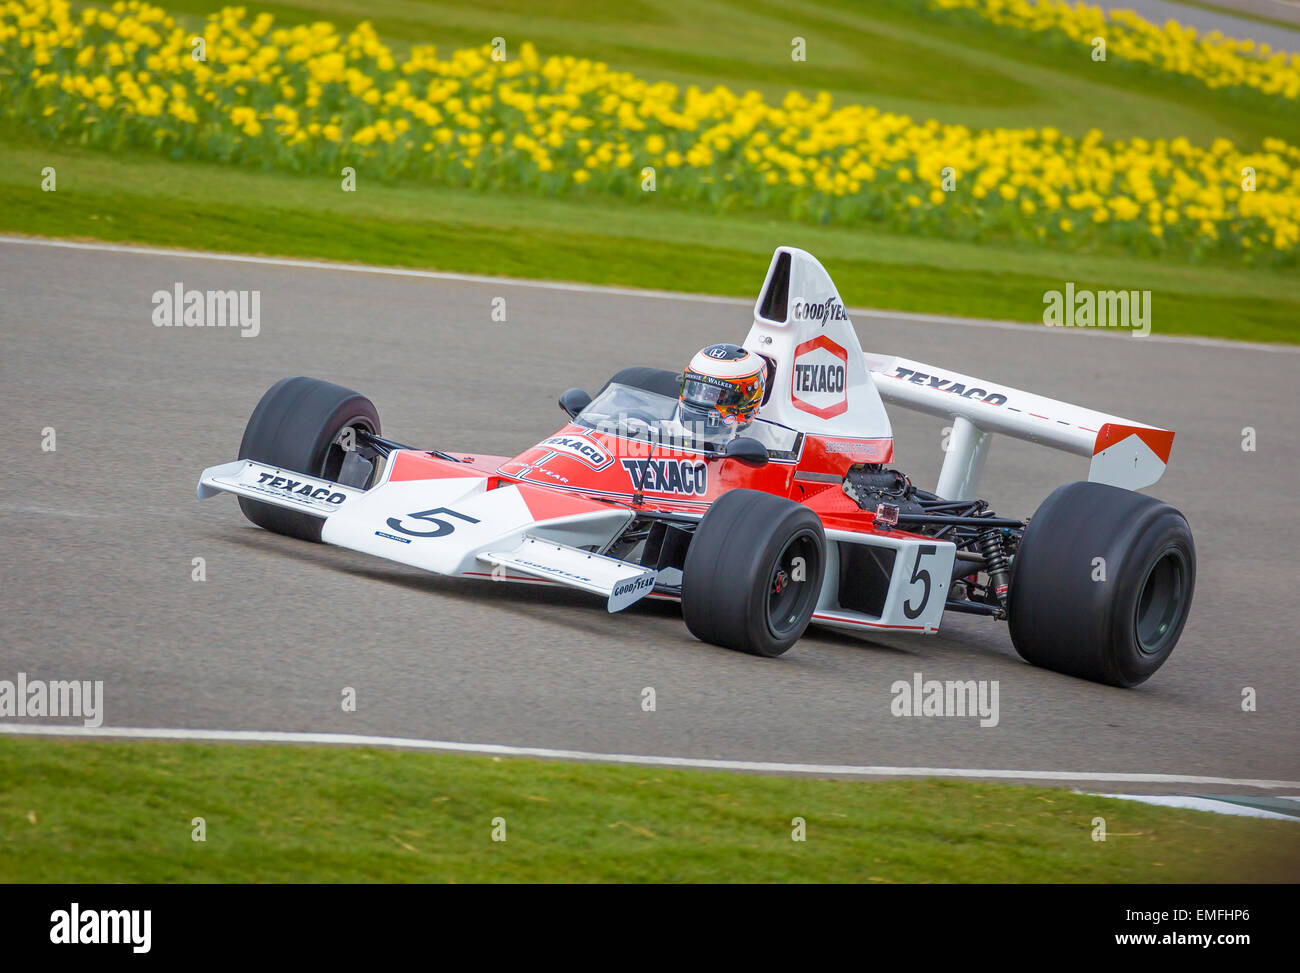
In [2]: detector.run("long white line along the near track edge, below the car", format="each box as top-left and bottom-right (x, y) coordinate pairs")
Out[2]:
(0, 723), (1300, 790)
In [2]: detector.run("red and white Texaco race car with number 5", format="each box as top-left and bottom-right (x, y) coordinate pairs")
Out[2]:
(199, 247), (1196, 686)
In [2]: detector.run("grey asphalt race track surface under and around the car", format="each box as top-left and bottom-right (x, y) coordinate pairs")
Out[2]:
(0, 242), (1300, 790)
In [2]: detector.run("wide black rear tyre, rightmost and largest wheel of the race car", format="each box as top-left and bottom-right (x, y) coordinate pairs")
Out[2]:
(1008, 483), (1196, 687)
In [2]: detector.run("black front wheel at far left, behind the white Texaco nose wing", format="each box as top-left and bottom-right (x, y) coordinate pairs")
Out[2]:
(239, 377), (380, 541)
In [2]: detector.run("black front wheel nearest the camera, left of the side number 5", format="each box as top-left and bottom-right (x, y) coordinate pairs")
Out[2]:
(681, 490), (826, 656)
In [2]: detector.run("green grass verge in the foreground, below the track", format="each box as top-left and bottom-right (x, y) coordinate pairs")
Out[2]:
(0, 739), (1300, 882)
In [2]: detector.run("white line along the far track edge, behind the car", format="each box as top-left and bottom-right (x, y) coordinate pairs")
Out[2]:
(0, 234), (1300, 354)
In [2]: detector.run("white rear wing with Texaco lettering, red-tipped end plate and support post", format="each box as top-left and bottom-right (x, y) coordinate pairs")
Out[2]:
(865, 354), (1174, 500)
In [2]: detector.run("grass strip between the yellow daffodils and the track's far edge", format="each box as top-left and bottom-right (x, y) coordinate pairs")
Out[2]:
(0, 131), (1300, 342)
